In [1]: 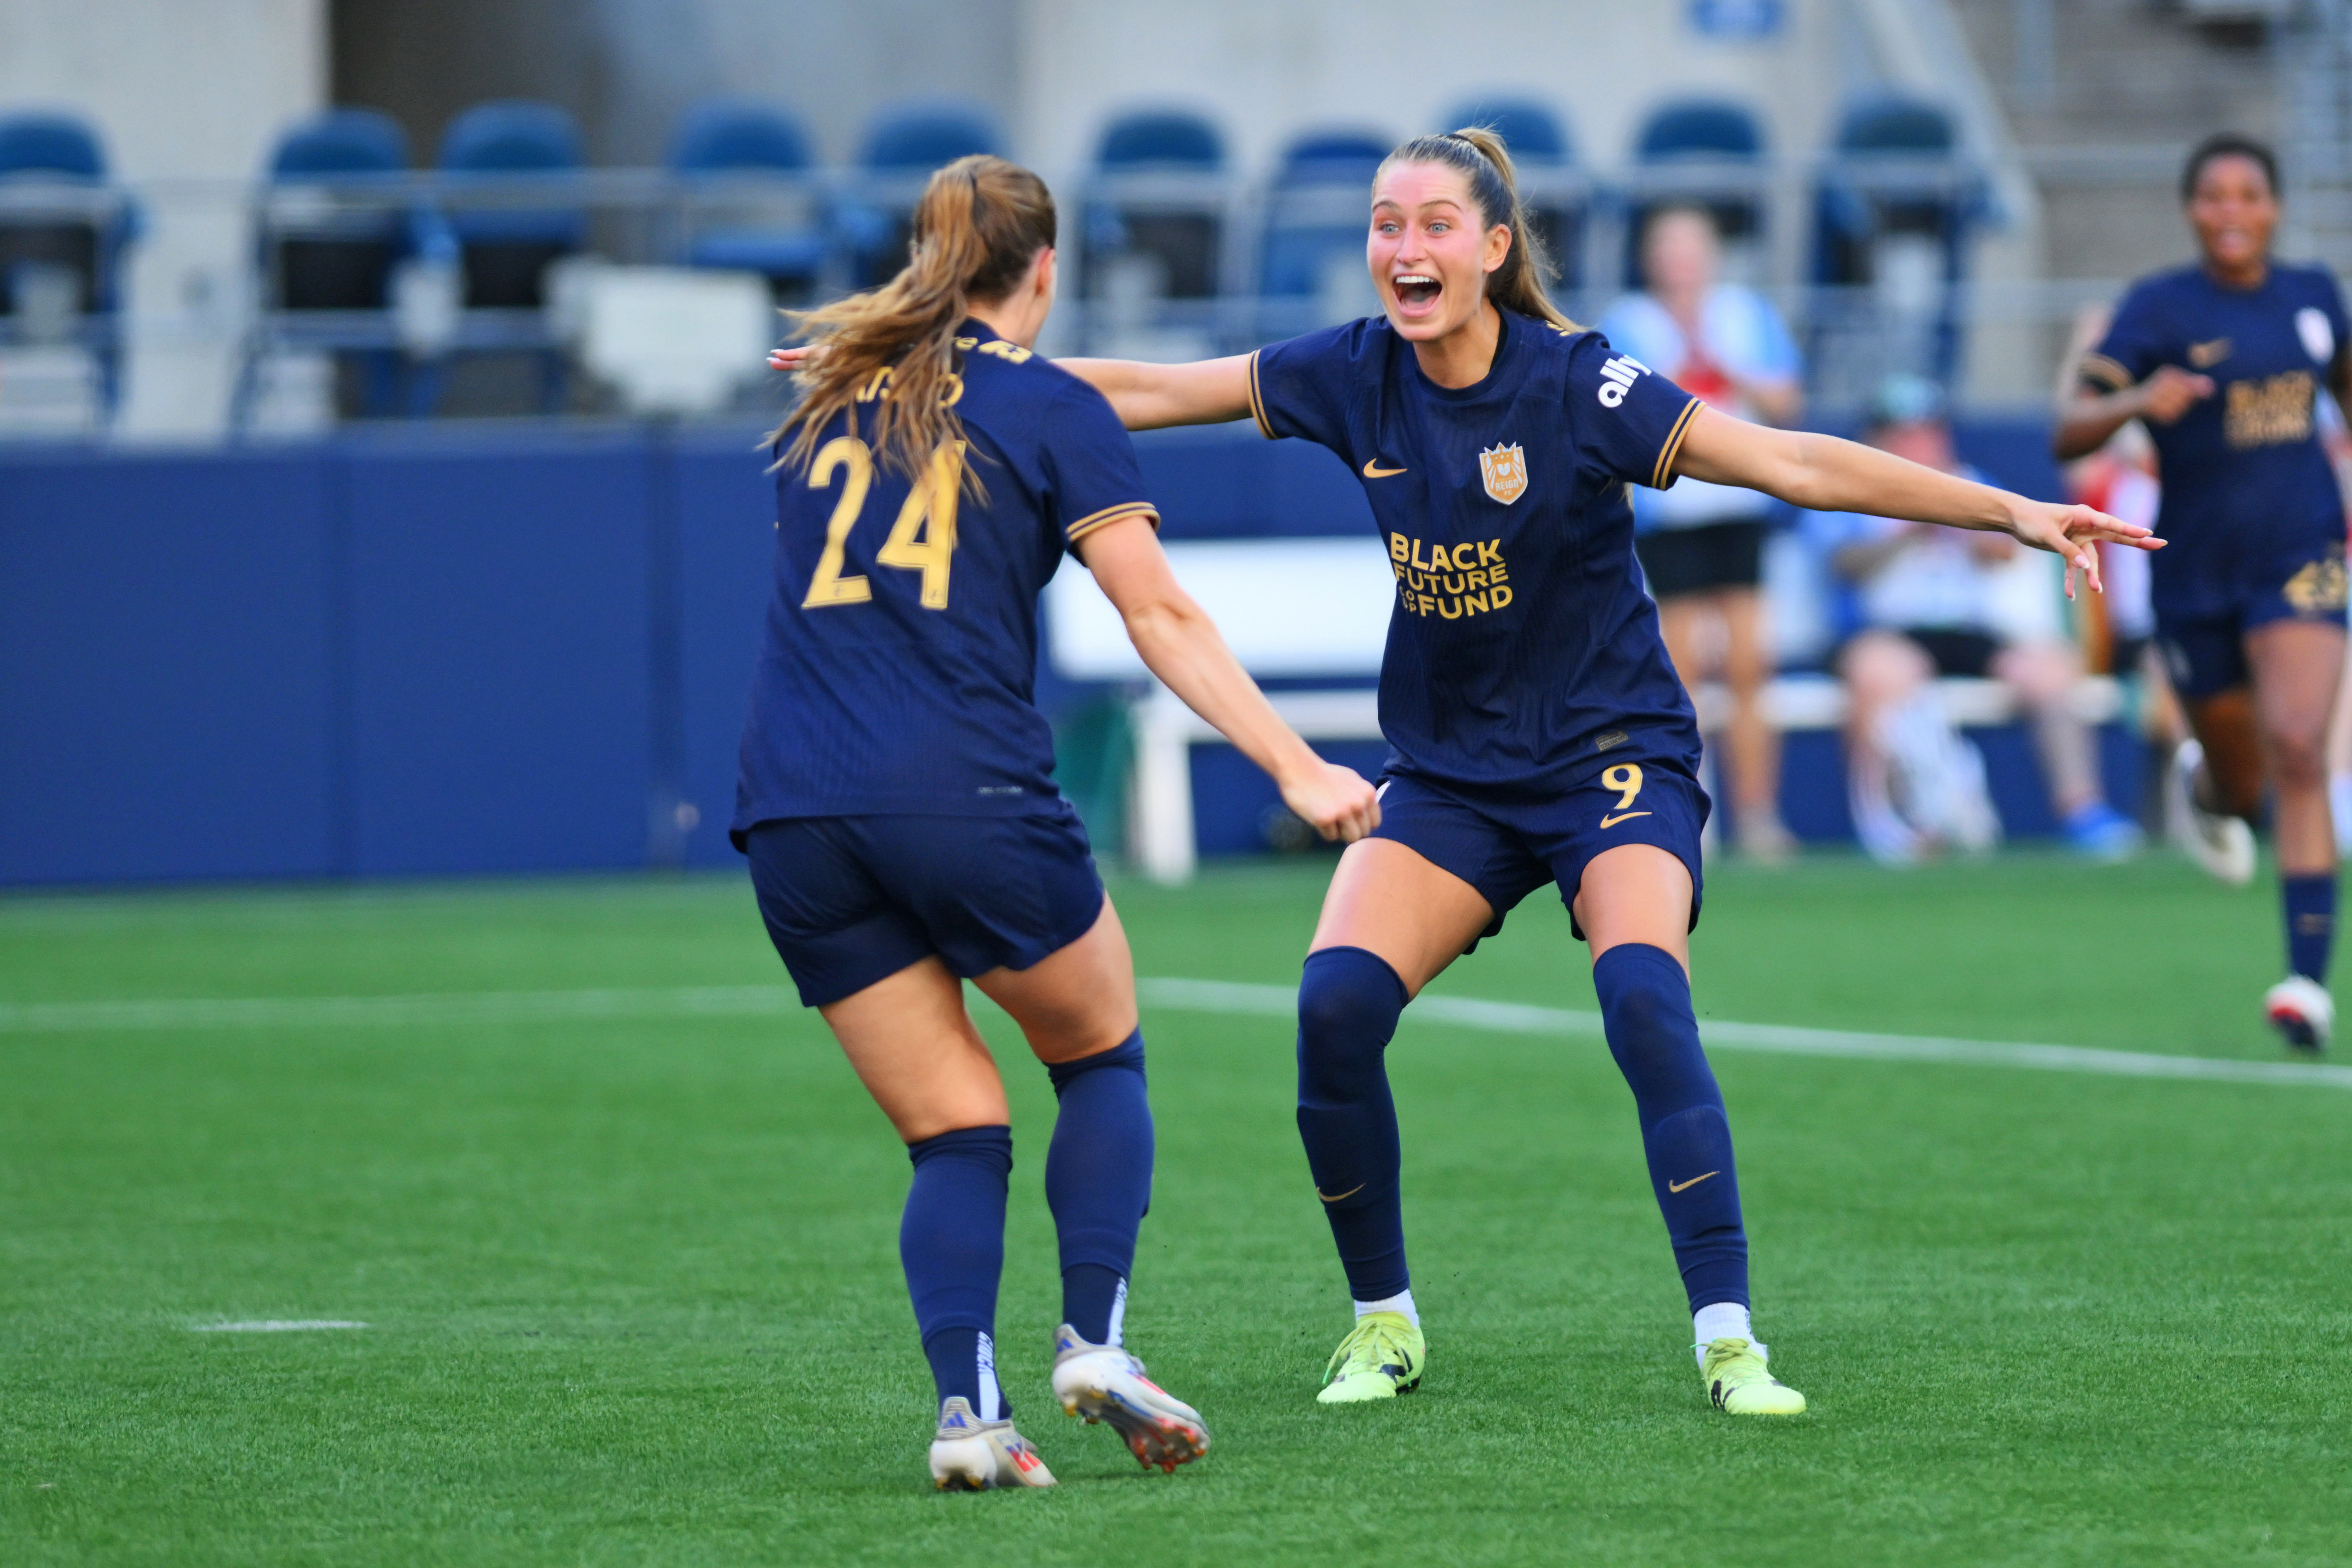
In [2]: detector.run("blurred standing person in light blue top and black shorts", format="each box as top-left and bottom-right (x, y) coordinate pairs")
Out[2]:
(1602, 207), (1804, 860)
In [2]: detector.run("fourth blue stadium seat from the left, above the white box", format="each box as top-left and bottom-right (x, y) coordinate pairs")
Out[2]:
(670, 99), (833, 301)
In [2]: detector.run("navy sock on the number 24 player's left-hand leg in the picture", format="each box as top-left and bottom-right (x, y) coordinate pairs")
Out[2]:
(899, 1126), (1014, 1420)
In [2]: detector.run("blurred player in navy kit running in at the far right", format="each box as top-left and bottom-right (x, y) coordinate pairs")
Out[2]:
(2053, 134), (2352, 1049)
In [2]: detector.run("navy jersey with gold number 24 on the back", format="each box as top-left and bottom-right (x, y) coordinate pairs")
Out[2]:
(734, 322), (1159, 846)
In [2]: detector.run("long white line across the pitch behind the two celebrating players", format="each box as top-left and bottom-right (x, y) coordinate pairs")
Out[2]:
(0, 978), (2352, 1088)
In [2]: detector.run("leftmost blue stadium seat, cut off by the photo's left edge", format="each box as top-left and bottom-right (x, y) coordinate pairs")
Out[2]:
(0, 113), (139, 416)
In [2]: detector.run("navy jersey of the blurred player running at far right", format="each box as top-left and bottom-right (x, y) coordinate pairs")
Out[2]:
(2082, 263), (2352, 616)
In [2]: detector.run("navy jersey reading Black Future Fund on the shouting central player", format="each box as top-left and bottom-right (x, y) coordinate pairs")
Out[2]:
(1249, 310), (1700, 794)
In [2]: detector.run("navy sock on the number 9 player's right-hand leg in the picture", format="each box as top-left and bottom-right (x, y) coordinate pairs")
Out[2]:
(1592, 943), (1747, 1312)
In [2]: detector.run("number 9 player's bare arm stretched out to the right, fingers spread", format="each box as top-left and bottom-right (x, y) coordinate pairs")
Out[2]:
(1675, 409), (2164, 600)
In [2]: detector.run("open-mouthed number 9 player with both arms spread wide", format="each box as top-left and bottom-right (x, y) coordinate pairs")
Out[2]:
(1066, 129), (2152, 1415)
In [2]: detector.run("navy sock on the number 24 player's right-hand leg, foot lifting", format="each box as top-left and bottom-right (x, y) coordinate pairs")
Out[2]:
(1044, 1030), (1152, 1345)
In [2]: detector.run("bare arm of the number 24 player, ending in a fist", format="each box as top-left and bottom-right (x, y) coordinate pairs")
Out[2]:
(1077, 517), (1381, 844)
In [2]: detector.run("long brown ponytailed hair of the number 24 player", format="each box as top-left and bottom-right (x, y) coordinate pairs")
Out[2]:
(769, 153), (1056, 487)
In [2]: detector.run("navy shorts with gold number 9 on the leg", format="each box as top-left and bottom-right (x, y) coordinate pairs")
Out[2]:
(1371, 762), (1712, 952)
